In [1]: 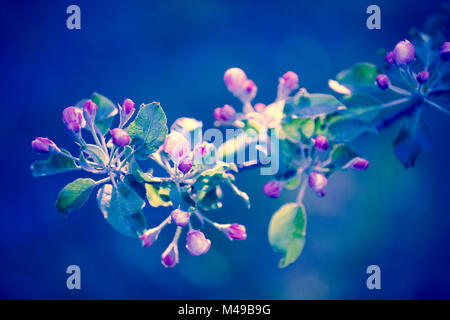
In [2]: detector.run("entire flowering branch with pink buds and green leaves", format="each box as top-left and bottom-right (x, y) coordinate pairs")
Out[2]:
(31, 24), (450, 268)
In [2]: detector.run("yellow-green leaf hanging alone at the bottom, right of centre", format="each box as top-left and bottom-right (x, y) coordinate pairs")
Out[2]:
(269, 203), (306, 268)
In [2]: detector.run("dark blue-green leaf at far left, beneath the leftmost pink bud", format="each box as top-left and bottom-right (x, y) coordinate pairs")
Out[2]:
(30, 149), (78, 177)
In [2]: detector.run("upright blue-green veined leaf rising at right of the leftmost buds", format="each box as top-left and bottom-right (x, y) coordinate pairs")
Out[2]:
(127, 102), (168, 160)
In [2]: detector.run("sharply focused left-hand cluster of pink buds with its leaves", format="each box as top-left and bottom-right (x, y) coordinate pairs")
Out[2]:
(31, 94), (247, 267)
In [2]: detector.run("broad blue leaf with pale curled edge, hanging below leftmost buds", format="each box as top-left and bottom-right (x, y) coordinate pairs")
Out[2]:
(97, 183), (146, 238)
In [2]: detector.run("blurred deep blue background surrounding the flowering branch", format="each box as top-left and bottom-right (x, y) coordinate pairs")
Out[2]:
(0, 0), (450, 299)
